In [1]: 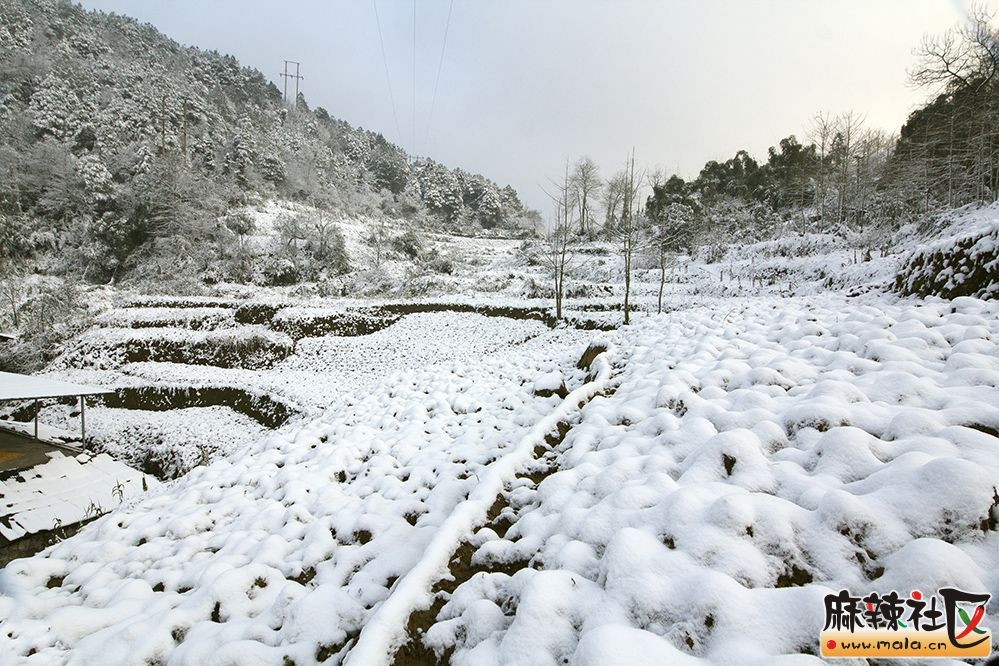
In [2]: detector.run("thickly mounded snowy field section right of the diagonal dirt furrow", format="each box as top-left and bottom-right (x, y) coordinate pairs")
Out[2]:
(426, 296), (999, 664)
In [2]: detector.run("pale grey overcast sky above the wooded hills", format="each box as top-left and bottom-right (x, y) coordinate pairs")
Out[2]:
(82, 0), (967, 213)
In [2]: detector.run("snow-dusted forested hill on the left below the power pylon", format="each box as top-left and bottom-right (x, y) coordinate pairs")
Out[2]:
(0, 0), (530, 280)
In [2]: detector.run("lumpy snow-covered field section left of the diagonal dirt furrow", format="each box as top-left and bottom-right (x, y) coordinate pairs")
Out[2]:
(0, 320), (600, 664)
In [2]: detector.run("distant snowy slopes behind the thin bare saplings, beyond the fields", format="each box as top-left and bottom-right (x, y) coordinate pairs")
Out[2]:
(214, 201), (999, 309)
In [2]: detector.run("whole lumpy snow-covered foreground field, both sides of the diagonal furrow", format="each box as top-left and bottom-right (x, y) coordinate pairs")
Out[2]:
(0, 294), (999, 666)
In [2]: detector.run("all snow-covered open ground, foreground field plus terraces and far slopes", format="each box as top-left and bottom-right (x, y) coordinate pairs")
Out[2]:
(0, 208), (999, 666)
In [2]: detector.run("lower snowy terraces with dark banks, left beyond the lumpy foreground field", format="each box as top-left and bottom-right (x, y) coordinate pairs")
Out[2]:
(31, 307), (590, 478)
